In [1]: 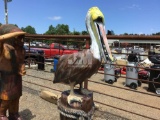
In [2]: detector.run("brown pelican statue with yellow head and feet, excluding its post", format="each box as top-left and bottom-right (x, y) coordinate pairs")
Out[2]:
(53, 7), (114, 105)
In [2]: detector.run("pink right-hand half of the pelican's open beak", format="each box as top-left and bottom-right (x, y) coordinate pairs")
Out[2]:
(96, 23), (114, 62)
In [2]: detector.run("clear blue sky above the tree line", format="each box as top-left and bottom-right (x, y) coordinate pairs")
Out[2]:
(0, 0), (160, 35)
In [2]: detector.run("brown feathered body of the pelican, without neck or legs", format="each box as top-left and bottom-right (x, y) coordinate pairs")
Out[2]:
(53, 50), (101, 84)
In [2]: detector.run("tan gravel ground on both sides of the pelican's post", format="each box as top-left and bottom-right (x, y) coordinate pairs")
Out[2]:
(19, 64), (160, 120)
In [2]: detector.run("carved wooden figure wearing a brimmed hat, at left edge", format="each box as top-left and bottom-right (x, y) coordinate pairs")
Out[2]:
(0, 24), (26, 120)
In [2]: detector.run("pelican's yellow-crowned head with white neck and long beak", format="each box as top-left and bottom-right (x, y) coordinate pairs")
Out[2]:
(86, 7), (114, 61)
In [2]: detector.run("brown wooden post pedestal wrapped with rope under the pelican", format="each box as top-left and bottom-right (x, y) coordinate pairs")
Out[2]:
(57, 89), (95, 120)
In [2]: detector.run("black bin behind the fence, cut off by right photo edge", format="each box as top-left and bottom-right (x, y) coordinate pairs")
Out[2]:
(148, 64), (160, 92)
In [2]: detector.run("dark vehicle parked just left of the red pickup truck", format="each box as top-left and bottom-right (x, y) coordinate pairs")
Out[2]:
(24, 45), (44, 64)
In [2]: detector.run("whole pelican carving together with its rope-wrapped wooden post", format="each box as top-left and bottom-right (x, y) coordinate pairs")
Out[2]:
(53, 7), (114, 120)
